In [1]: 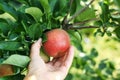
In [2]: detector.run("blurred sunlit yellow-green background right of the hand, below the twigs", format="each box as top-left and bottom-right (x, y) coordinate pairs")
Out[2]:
(66, 29), (120, 80)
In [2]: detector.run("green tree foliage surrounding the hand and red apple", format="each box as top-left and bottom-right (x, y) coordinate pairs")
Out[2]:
(0, 0), (120, 80)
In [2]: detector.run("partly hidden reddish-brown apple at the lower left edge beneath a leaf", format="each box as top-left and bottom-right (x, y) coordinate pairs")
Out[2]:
(0, 64), (14, 77)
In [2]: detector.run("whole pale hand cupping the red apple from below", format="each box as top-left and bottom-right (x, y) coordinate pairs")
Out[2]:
(24, 38), (74, 80)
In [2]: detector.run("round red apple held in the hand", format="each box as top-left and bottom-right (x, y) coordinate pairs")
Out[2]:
(43, 29), (70, 58)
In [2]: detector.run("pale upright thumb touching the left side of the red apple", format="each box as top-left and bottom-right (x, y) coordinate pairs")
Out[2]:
(30, 38), (42, 59)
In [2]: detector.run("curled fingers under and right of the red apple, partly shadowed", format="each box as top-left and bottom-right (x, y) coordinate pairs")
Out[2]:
(48, 46), (74, 72)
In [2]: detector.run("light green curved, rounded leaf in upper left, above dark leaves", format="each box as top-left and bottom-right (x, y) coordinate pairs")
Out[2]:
(25, 7), (43, 22)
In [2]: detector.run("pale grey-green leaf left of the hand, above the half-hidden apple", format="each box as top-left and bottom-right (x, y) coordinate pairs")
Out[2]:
(2, 54), (30, 68)
